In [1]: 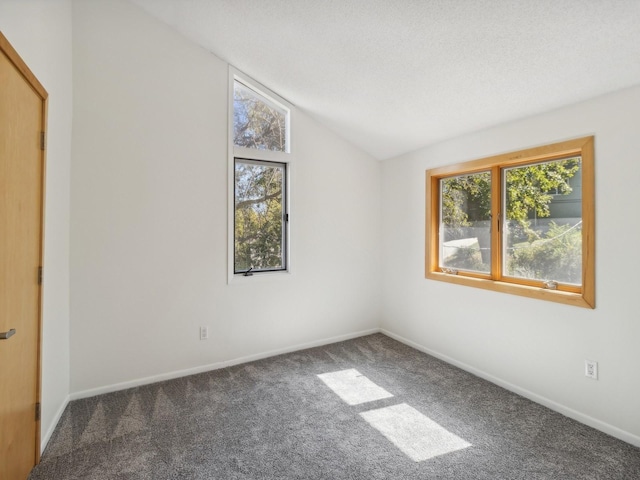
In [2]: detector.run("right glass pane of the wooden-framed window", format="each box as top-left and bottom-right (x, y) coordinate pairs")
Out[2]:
(502, 157), (582, 285)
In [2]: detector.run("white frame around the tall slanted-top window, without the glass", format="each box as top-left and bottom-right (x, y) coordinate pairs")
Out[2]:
(227, 66), (295, 285)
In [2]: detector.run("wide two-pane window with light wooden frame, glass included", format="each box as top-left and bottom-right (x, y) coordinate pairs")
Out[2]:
(426, 137), (595, 308)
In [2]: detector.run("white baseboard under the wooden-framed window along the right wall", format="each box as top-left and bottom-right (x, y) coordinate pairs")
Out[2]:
(380, 328), (640, 447)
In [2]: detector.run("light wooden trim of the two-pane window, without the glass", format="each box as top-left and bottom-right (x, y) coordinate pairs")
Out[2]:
(425, 136), (595, 308)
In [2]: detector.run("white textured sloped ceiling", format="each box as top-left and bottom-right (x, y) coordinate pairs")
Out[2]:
(132, 0), (640, 159)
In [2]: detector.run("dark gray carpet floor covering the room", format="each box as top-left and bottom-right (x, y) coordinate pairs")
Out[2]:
(29, 334), (640, 480)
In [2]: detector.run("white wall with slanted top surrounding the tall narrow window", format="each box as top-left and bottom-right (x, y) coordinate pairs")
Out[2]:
(71, 0), (381, 396)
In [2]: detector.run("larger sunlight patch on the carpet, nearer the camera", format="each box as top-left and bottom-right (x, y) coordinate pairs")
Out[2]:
(360, 403), (471, 462)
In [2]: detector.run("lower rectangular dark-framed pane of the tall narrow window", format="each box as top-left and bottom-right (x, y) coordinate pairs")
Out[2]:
(234, 159), (286, 273)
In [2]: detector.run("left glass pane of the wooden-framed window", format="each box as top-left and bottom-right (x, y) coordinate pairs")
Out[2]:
(440, 172), (491, 273)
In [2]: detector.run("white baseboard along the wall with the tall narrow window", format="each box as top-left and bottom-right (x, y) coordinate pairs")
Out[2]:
(69, 328), (380, 400)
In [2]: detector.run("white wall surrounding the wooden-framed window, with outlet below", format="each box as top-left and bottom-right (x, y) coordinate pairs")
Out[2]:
(382, 87), (640, 446)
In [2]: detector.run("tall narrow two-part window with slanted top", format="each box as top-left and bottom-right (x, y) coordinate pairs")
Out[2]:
(229, 74), (291, 279)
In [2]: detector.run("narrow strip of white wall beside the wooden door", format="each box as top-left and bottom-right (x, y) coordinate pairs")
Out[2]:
(0, 0), (72, 448)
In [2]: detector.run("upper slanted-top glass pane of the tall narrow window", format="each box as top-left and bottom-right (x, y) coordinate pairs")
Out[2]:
(233, 81), (288, 152)
